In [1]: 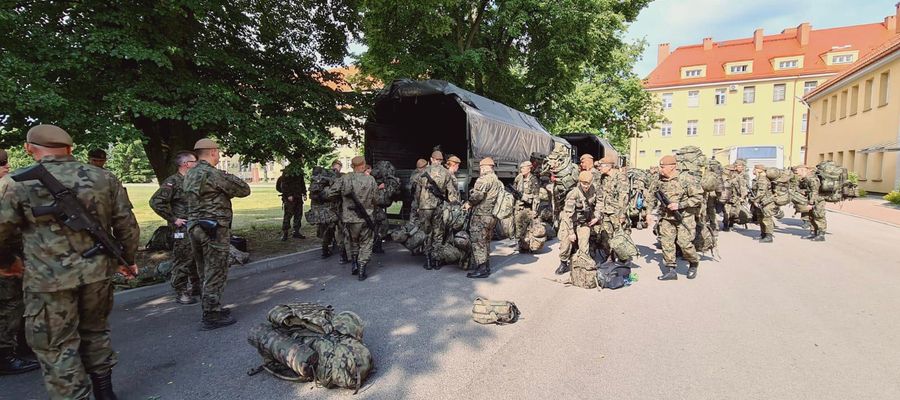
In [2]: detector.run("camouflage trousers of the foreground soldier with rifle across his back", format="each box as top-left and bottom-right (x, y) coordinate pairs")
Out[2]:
(25, 279), (117, 399)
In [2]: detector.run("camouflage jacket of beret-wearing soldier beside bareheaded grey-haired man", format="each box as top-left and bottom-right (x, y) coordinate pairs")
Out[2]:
(183, 160), (250, 228)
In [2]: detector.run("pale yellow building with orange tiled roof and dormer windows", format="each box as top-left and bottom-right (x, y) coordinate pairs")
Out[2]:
(630, 8), (897, 168)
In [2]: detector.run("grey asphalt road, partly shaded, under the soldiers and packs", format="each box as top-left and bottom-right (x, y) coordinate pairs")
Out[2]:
(0, 213), (900, 400)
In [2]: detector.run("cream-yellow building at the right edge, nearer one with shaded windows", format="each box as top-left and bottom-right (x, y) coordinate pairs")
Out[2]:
(805, 30), (900, 193)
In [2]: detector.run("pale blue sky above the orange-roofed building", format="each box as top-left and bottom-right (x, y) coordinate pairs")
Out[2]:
(625, 0), (898, 78)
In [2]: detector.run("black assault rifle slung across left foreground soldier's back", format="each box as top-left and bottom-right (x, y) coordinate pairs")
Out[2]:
(12, 164), (132, 266)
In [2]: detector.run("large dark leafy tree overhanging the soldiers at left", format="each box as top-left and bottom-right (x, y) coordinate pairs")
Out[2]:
(0, 0), (365, 179)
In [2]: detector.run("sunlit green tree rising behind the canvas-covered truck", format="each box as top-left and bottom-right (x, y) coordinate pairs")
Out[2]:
(359, 0), (652, 149)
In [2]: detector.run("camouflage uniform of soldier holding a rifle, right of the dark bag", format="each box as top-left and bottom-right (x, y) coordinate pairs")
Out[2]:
(659, 173), (703, 267)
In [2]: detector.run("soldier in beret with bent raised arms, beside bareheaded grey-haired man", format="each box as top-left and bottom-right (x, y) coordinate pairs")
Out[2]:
(183, 139), (250, 331)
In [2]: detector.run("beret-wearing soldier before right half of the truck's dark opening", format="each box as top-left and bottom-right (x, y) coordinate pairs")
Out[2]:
(417, 151), (459, 270)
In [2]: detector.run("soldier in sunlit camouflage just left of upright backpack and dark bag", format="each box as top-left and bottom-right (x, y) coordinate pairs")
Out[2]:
(556, 171), (597, 275)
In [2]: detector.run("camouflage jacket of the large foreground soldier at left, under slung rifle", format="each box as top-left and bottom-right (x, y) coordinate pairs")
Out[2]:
(0, 156), (140, 292)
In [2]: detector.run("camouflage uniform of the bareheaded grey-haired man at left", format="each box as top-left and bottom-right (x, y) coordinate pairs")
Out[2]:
(150, 172), (202, 294)
